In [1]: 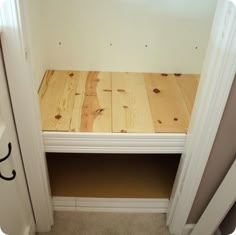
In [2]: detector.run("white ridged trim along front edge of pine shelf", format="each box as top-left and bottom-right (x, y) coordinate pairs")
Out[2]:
(42, 131), (186, 154)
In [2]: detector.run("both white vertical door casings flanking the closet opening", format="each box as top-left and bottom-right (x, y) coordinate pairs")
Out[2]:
(2, 0), (236, 234)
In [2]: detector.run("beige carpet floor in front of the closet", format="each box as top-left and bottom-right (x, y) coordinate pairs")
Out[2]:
(39, 212), (170, 235)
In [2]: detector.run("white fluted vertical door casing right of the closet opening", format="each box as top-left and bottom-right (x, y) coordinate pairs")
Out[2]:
(167, 0), (236, 234)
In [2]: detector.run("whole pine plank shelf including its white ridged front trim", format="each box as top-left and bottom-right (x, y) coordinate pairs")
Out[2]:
(39, 70), (199, 153)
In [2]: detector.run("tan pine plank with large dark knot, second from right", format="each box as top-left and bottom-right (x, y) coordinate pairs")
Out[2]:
(145, 74), (190, 133)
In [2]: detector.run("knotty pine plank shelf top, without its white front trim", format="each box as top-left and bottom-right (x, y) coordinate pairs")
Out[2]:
(39, 70), (199, 133)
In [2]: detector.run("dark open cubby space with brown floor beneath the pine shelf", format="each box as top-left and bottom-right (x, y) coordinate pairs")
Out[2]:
(47, 153), (179, 198)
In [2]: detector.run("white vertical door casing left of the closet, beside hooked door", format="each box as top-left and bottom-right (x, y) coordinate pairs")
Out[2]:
(1, 0), (53, 232)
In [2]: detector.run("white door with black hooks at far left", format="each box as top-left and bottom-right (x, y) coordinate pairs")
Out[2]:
(0, 43), (34, 235)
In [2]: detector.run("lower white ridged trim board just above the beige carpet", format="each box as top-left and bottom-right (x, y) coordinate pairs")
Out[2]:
(53, 197), (169, 213)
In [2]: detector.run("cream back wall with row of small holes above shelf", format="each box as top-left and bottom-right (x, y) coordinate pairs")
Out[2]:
(38, 0), (216, 73)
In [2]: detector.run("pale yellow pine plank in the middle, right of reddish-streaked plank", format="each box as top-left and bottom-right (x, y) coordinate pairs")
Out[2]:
(112, 73), (154, 133)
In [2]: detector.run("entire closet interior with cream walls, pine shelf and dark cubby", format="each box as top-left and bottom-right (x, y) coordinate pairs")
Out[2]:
(28, 0), (216, 210)
